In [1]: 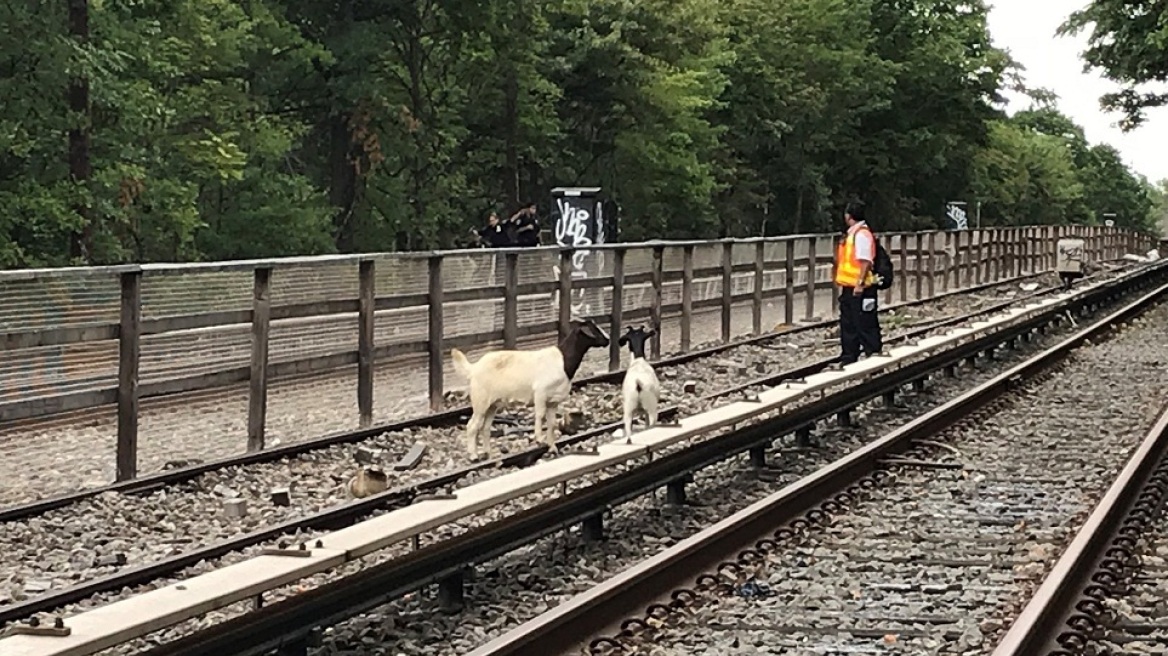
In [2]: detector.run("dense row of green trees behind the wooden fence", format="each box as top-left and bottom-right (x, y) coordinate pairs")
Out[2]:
(0, 0), (1163, 267)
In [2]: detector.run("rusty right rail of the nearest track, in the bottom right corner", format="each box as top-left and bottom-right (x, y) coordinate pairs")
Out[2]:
(993, 399), (1168, 656)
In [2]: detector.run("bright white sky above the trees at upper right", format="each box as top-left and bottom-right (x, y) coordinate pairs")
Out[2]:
(989, 0), (1168, 182)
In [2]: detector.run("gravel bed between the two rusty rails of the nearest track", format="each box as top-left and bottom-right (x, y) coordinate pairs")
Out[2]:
(576, 296), (1168, 655)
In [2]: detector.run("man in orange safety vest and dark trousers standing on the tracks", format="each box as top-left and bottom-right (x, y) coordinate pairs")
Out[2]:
(835, 201), (883, 364)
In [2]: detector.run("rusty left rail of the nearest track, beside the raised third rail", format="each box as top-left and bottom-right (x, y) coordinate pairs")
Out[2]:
(467, 275), (1168, 656)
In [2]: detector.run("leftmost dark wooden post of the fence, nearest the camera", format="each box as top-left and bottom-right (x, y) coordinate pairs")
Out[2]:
(116, 270), (142, 481)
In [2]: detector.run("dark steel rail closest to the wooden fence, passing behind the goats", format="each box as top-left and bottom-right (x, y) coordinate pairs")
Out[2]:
(0, 271), (1058, 522)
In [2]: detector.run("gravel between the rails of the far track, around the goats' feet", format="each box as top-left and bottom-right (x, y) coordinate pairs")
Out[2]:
(0, 271), (1093, 607)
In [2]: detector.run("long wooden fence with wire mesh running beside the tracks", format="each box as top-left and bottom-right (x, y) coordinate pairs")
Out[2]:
(0, 221), (1155, 480)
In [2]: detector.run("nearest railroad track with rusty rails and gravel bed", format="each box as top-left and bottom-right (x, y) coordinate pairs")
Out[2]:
(460, 269), (1168, 656)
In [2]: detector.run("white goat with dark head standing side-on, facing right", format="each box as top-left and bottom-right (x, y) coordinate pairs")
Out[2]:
(450, 320), (609, 459)
